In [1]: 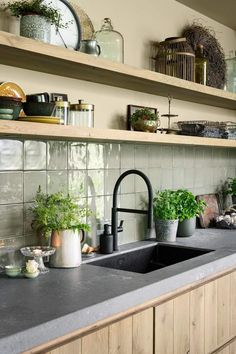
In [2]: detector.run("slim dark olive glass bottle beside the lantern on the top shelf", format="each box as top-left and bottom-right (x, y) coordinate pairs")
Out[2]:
(195, 44), (208, 85)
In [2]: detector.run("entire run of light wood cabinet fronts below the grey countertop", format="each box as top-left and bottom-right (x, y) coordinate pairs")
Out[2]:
(44, 272), (236, 354)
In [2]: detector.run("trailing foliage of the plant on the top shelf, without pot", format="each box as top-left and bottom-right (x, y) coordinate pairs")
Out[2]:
(3, 0), (68, 28)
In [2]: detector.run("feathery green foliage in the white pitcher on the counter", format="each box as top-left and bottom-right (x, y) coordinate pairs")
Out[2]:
(31, 188), (91, 235)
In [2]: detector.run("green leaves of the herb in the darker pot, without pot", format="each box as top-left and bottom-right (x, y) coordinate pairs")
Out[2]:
(176, 189), (206, 221)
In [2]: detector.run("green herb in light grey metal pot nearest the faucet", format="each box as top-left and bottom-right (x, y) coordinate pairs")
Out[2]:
(153, 189), (179, 242)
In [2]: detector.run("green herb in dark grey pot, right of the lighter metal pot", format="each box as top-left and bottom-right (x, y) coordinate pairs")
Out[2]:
(177, 189), (206, 237)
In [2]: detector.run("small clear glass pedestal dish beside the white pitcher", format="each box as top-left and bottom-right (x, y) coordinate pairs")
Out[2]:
(20, 246), (56, 274)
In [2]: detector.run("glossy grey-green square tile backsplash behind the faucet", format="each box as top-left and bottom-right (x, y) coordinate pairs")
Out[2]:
(0, 139), (236, 265)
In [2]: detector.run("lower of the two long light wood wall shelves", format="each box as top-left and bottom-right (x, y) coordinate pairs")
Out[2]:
(0, 120), (236, 148)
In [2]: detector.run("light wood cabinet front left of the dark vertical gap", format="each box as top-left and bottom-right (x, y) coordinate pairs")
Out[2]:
(47, 308), (153, 354)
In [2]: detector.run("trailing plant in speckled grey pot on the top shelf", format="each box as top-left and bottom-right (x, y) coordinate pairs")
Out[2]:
(4, 0), (67, 43)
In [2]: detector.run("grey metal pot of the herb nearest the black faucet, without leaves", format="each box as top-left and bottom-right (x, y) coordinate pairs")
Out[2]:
(155, 219), (178, 242)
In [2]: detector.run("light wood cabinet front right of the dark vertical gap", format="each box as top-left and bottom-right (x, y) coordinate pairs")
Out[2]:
(155, 272), (236, 354)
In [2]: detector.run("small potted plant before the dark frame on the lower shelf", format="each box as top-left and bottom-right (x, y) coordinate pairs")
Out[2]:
(130, 108), (160, 133)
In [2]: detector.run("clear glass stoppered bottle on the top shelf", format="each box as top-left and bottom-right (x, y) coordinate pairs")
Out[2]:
(95, 17), (124, 63)
